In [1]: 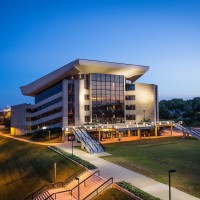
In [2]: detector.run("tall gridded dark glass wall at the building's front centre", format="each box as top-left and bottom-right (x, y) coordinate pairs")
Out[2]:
(91, 74), (124, 123)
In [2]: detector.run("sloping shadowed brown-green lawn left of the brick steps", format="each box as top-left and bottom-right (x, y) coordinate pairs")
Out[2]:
(0, 136), (83, 200)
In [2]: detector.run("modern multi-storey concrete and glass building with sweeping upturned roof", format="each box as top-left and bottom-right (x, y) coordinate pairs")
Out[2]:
(11, 59), (159, 134)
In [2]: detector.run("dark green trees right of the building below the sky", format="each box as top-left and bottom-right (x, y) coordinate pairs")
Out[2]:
(159, 97), (200, 125)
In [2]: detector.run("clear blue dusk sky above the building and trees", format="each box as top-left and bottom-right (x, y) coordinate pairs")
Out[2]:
(0, 0), (200, 108)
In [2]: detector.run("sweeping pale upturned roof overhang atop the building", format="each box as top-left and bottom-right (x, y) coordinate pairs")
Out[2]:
(20, 59), (149, 96)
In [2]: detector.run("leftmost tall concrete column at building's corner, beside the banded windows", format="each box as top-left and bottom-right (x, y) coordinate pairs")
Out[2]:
(62, 79), (68, 142)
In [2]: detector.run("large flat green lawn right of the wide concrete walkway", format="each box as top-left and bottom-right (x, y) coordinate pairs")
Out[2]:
(104, 138), (200, 197)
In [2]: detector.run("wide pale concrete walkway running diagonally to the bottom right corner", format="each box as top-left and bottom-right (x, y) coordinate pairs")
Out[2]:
(55, 143), (199, 200)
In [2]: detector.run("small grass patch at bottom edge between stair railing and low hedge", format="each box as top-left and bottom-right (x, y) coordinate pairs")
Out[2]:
(94, 188), (132, 200)
